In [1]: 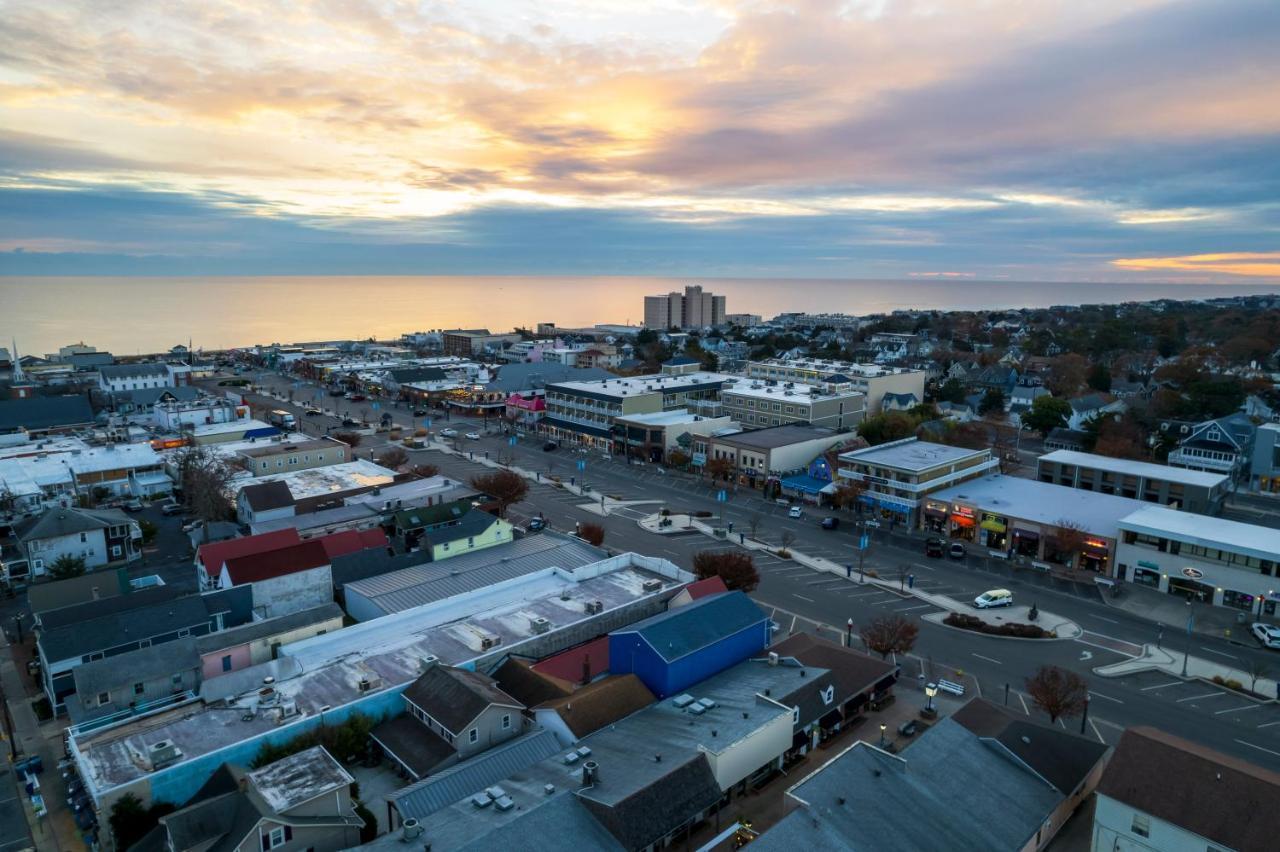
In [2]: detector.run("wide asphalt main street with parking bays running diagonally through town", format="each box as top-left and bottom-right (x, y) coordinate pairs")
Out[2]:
(225, 368), (1280, 762)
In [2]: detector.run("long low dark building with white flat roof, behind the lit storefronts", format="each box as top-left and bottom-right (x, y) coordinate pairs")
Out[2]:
(1036, 450), (1230, 514)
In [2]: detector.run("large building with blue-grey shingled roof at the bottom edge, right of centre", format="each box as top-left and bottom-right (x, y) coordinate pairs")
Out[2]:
(751, 719), (1100, 852)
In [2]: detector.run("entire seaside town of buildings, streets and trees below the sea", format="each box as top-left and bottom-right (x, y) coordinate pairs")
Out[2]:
(0, 284), (1280, 852)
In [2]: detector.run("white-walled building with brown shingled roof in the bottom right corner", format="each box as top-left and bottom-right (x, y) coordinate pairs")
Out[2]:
(1089, 727), (1280, 852)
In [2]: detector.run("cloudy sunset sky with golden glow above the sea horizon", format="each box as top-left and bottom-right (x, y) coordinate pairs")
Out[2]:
(0, 0), (1280, 283)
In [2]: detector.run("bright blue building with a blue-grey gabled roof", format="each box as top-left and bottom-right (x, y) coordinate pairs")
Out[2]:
(609, 591), (769, 698)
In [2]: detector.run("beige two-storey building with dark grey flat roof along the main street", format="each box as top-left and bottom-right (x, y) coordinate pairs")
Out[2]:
(695, 423), (858, 489)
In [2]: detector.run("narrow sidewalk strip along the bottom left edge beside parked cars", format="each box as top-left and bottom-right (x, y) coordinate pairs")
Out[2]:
(0, 641), (87, 852)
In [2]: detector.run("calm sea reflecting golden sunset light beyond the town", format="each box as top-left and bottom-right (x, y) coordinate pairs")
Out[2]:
(0, 276), (1280, 354)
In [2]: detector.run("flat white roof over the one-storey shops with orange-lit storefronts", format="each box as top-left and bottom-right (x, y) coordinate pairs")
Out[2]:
(928, 473), (1146, 539)
